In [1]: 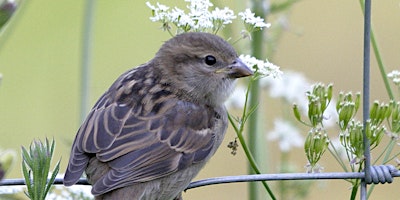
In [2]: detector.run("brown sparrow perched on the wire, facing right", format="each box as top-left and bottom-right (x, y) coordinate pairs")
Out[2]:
(64, 32), (253, 200)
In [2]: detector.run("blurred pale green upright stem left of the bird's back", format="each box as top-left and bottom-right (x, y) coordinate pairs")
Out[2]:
(80, 0), (95, 122)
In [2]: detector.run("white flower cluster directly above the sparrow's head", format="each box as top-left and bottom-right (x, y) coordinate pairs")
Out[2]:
(146, 0), (270, 35)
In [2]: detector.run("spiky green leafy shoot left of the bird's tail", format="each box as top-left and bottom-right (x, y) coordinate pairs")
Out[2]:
(22, 138), (60, 200)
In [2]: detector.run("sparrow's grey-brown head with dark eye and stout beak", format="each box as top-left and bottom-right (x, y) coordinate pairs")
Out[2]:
(153, 33), (253, 105)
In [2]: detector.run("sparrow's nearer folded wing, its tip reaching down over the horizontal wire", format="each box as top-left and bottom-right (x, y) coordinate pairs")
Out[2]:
(90, 100), (222, 194)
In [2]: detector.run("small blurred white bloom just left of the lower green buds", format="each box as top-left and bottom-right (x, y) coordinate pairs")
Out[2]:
(267, 119), (304, 152)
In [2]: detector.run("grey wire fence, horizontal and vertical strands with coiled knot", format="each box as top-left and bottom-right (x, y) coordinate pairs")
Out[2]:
(0, 0), (400, 200)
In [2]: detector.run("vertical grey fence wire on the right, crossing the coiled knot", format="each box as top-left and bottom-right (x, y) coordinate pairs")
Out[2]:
(360, 0), (371, 200)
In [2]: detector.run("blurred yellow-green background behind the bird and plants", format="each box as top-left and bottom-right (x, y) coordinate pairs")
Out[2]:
(0, 0), (400, 199)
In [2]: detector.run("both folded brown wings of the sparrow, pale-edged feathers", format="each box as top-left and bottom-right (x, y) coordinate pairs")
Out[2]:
(64, 70), (226, 194)
